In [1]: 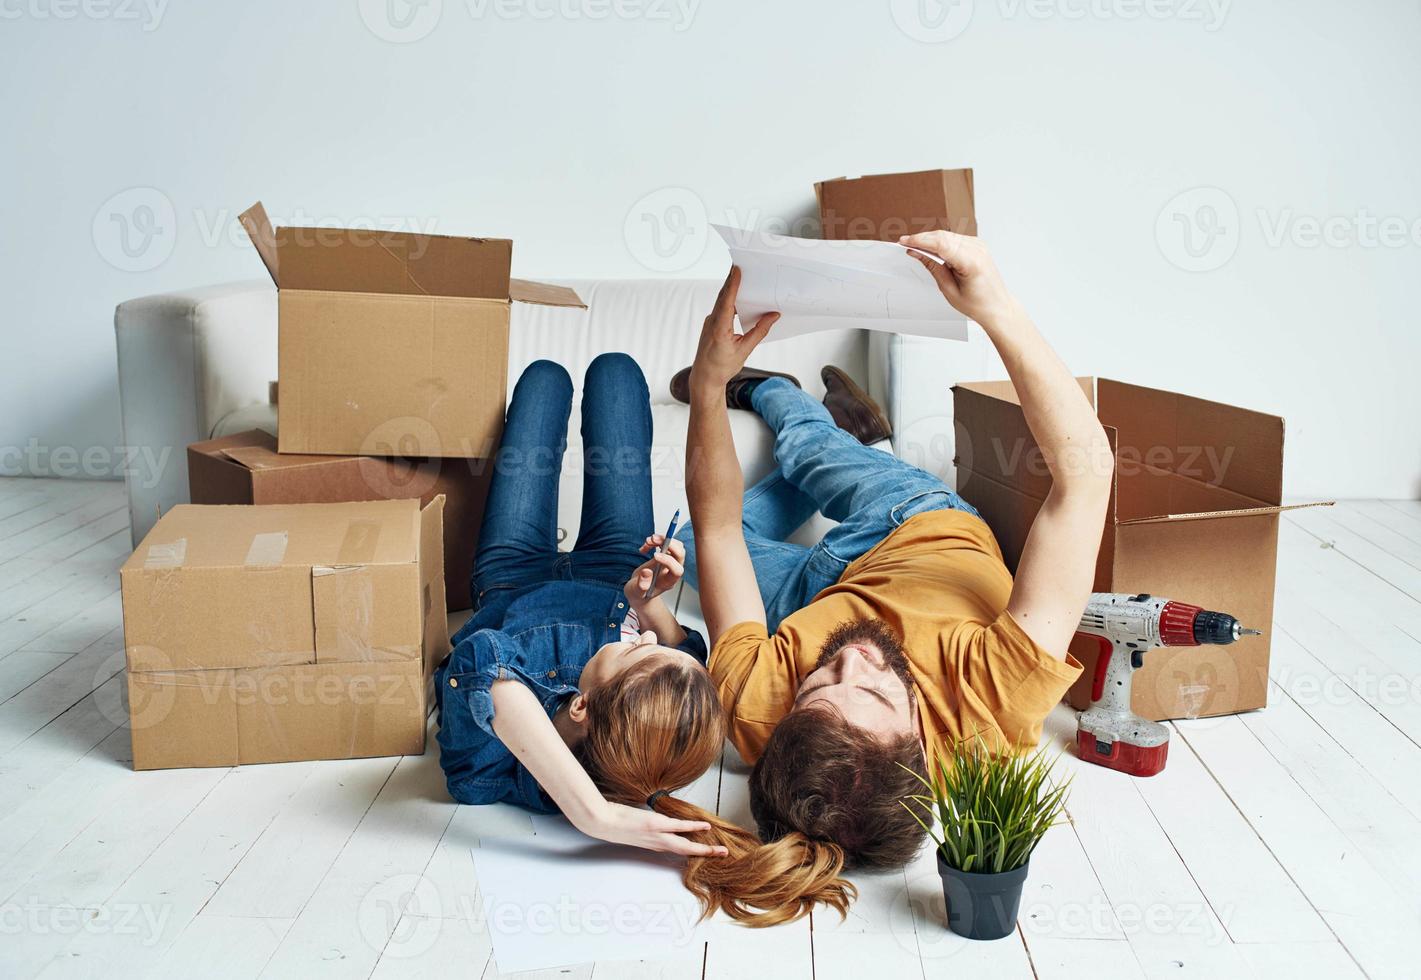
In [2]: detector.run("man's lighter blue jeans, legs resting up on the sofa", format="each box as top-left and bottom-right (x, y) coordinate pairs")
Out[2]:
(678, 378), (978, 632)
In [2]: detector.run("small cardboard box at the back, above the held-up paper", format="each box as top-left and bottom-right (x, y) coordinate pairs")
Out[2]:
(814, 169), (976, 241)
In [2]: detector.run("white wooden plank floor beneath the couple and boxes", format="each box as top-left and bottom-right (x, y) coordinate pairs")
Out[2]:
(0, 480), (1421, 980)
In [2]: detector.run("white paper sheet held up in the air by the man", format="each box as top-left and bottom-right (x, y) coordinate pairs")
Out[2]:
(712, 224), (969, 342)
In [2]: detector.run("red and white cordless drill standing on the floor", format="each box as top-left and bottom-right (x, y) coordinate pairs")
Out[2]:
(1076, 592), (1262, 775)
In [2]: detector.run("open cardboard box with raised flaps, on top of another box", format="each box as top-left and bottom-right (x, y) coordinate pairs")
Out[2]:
(242, 203), (583, 459)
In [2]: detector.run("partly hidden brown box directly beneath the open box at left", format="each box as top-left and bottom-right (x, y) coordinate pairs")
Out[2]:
(188, 429), (493, 609)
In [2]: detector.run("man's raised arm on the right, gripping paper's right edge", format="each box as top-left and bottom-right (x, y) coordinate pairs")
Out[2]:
(901, 232), (1114, 659)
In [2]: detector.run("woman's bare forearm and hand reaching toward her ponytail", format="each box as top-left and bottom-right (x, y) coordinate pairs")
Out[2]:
(490, 679), (726, 858)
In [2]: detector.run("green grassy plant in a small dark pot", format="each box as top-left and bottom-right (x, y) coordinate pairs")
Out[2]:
(902, 736), (1070, 939)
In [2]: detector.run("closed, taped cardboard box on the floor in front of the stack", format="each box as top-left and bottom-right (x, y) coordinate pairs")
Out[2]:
(119, 497), (449, 768)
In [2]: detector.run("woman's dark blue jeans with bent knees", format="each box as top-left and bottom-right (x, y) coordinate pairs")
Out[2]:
(473, 354), (652, 596)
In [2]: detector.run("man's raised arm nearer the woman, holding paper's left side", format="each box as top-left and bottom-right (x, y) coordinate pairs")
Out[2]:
(686, 268), (779, 646)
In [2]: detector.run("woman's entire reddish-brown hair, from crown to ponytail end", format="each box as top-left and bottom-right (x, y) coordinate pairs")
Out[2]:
(574, 662), (855, 926)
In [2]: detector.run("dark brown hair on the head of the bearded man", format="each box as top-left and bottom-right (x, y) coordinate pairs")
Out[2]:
(750, 698), (926, 868)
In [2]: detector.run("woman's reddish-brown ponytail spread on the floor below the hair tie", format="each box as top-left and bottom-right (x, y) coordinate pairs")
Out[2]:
(654, 795), (857, 926)
